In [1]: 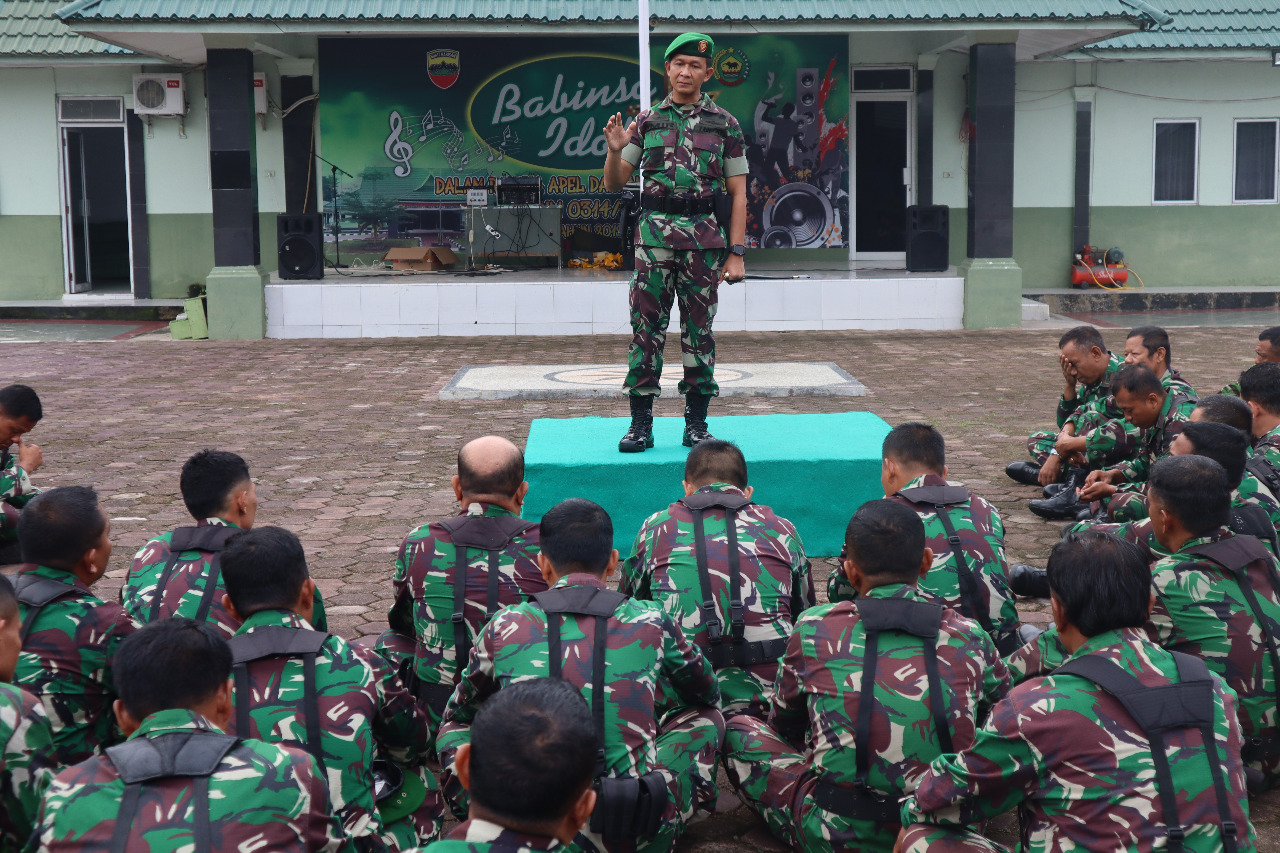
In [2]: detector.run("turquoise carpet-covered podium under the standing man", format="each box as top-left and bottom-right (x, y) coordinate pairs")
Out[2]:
(524, 411), (890, 560)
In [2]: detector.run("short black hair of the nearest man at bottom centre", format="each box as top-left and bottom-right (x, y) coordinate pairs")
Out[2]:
(471, 679), (599, 824)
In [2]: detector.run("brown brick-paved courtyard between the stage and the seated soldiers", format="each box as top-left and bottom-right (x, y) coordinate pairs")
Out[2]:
(0, 327), (1280, 852)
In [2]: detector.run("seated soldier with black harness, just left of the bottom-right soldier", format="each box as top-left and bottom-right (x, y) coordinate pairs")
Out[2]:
(724, 501), (1009, 853)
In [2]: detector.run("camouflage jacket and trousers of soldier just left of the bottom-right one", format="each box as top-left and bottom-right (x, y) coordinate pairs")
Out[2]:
(724, 584), (1009, 853)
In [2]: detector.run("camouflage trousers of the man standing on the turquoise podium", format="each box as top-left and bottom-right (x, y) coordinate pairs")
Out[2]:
(622, 246), (726, 397)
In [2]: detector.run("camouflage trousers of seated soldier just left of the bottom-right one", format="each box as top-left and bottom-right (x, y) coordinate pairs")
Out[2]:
(724, 716), (900, 853)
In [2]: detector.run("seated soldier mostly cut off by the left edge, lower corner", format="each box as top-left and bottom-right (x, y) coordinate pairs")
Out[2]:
(0, 575), (54, 850)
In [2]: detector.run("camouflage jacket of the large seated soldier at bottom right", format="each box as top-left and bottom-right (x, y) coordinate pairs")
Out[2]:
(902, 629), (1256, 853)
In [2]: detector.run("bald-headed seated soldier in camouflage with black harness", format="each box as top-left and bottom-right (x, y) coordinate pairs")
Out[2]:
(378, 435), (547, 731)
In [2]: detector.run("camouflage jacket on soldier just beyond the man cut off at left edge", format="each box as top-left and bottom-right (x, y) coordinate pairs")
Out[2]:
(14, 564), (138, 766)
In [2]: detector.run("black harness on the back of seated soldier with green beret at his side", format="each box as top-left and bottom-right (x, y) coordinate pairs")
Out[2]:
(227, 625), (330, 777)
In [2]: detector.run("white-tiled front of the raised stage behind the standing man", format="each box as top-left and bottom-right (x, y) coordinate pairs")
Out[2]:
(266, 261), (964, 338)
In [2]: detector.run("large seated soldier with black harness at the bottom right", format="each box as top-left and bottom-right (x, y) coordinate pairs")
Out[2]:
(901, 527), (1256, 853)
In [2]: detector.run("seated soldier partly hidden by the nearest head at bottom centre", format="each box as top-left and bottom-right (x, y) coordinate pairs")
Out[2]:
(436, 498), (724, 853)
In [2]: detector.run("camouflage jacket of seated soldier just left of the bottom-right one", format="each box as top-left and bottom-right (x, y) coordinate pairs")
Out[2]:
(769, 584), (1009, 793)
